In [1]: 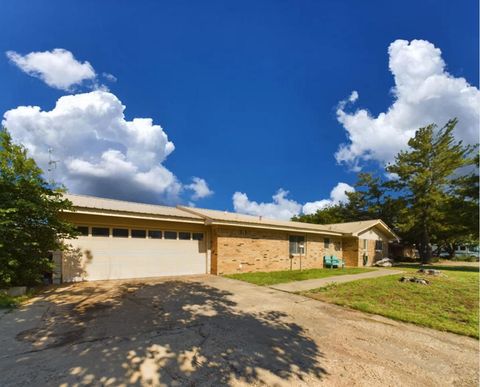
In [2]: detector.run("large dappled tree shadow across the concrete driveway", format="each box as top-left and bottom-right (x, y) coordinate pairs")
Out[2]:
(7, 280), (326, 386)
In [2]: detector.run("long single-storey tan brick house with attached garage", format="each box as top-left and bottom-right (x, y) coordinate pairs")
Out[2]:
(54, 194), (398, 282)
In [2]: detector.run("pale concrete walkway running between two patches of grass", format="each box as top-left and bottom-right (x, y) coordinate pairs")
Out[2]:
(270, 269), (403, 293)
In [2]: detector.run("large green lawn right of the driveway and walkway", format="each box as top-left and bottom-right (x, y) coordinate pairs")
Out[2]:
(302, 265), (479, 339)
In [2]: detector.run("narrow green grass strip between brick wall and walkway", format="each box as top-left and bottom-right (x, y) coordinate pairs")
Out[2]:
(225, 267), (374, 286)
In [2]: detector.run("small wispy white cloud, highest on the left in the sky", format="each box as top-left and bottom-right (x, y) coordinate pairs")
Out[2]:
(6, 48), (96, 91)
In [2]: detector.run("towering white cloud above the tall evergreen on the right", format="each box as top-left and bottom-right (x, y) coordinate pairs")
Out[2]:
(335, 40), (480, 171)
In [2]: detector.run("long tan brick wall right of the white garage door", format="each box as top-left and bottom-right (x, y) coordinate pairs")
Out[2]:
(212, 227), (342, 274)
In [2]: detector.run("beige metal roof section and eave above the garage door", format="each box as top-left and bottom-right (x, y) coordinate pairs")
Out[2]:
(63, 194), (204, 224)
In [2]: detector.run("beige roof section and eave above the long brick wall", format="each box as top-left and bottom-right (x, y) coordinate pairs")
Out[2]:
(177, 206), (342, 236)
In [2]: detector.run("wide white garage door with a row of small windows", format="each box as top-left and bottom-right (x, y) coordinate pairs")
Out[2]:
(63, 227), (207, 282)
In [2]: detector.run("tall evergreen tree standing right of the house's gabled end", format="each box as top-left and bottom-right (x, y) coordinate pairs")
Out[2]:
(387, 119), (473, 262)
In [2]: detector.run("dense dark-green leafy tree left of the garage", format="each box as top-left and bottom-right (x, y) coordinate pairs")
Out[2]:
(0, 128), (76, 287)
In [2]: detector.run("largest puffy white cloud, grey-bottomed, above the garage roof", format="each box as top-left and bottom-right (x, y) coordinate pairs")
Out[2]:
(2, 90), (211, 204)
